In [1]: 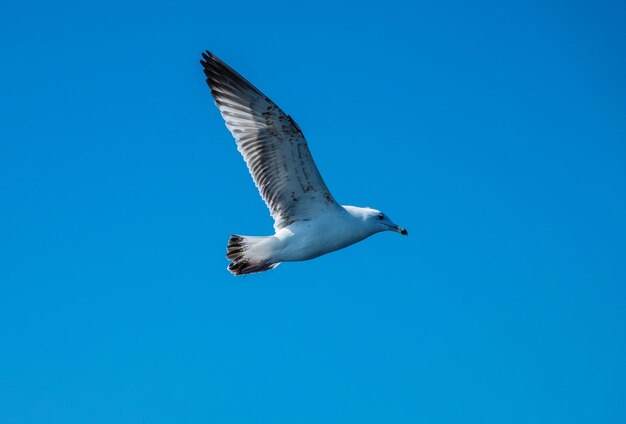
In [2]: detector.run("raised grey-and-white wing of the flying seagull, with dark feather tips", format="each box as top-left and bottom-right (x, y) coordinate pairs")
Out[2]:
(200, 51), (339, 230)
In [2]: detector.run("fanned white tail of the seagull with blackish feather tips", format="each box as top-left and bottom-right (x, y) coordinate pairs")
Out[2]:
(226, 234), (280, 275)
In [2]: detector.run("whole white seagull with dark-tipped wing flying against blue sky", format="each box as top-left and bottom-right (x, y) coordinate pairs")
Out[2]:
(200, 51), (408, 275)
